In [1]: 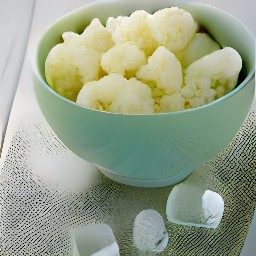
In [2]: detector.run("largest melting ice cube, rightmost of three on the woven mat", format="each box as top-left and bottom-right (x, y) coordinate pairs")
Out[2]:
(166, 183), (224, 228)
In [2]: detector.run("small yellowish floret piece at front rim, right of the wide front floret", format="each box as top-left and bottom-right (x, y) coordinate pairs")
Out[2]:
(160, 93), (185, 112)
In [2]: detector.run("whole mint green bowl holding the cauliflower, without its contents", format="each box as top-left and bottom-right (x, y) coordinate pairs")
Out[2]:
(32, 0), (255, 187)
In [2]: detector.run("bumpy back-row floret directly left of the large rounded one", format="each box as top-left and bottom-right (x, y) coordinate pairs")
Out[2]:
(106, 10), (158, 56)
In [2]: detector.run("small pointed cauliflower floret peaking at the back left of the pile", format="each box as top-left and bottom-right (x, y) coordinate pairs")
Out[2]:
(80, 18), (114, 53)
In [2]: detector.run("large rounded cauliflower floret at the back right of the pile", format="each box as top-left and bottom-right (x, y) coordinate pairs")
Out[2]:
(150, 7), (198, 52)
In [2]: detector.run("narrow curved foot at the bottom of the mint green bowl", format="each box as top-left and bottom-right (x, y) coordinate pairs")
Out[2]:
(96, 165), (191, 188)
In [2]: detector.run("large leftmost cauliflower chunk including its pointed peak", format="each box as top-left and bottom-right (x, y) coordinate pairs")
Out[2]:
(45, 19), (114, 101)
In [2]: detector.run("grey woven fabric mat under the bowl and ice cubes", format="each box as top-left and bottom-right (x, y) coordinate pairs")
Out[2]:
(0, 99), (256, 256)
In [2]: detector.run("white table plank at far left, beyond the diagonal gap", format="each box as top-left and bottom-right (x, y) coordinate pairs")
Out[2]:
(0, 0), (35, 149)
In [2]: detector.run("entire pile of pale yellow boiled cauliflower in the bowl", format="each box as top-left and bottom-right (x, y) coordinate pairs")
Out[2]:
(45, 7), (242, 114)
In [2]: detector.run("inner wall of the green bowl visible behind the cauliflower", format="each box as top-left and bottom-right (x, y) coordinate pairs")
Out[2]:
(36, 0), (255, 96)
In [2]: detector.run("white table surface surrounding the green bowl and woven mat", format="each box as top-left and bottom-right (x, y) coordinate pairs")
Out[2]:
(0, 0), (256, 256)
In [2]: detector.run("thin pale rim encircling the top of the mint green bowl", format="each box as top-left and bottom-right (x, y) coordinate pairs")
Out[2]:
(31, 0), (255, 117)
